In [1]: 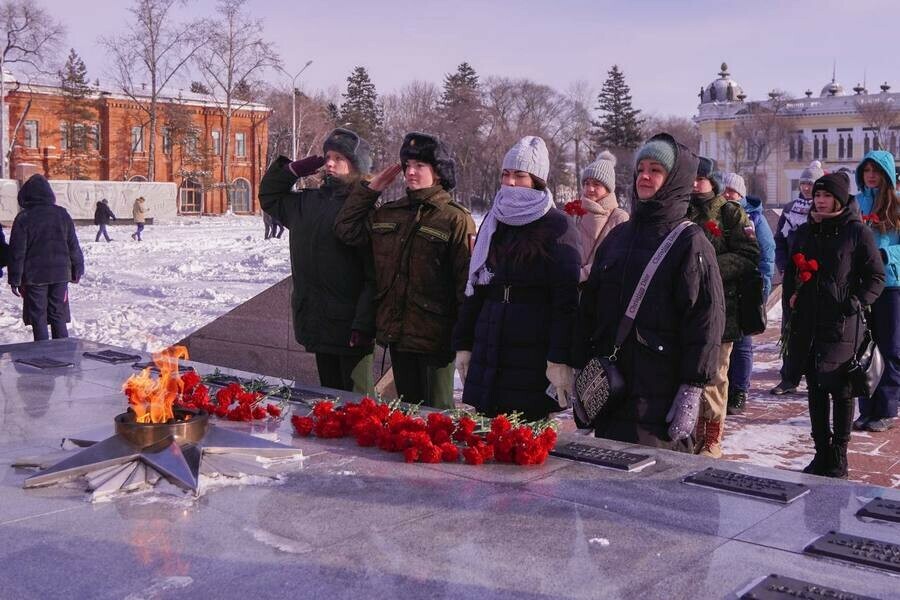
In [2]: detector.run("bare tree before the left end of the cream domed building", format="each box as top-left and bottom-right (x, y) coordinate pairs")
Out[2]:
(732, 91), (797, 201)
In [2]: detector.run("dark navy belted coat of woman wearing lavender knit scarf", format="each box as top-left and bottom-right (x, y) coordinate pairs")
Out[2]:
(453, 208), (581, 420)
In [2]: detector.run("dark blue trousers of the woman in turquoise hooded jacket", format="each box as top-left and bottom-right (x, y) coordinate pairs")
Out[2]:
(859, 288), (900, 419)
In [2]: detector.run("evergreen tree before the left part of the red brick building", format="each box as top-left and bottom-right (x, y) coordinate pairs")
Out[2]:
(58, 49), (100, 179)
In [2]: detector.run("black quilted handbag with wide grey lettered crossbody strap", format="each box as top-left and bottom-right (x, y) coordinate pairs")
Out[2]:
(572, 221), (693, 429)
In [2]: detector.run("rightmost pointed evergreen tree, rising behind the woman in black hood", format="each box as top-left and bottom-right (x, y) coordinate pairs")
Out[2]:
(593, 65), (643, 150)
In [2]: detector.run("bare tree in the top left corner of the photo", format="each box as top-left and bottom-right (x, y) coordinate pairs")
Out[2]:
(0, 0), (65, 179)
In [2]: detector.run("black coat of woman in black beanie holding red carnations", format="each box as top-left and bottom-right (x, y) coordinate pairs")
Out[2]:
(784, 199), (884, 398)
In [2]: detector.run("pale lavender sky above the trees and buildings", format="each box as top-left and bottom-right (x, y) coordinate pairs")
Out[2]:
(34, 0), (900, 116)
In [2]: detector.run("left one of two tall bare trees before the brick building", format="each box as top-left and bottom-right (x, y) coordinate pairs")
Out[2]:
(100, 0), (204, 181)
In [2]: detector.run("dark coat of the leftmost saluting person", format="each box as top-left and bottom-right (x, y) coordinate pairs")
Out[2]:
(259, 156), (375, 356)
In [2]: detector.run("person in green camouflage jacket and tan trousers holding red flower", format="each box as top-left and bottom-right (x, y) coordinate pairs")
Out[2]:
(688, 156), (759, 458)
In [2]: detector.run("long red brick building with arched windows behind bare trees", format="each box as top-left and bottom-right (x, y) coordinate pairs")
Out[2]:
(4, 75), (271, 214)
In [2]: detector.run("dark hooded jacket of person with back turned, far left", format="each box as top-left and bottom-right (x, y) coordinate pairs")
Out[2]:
(9, 174), (84, 286)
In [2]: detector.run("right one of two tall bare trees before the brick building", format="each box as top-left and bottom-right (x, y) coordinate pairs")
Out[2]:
(194, 0), (281, 207)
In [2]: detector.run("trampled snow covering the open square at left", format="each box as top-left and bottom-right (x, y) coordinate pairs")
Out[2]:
(0, 215), (290, 350)
